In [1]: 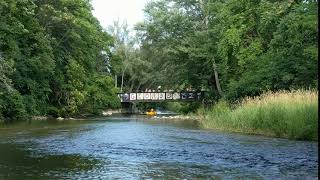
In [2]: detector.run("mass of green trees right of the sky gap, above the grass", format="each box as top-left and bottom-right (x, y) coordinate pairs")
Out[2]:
(130, 0), (318, 101)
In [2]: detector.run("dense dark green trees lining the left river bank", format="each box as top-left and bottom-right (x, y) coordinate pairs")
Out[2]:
(0, 0), (119, 120)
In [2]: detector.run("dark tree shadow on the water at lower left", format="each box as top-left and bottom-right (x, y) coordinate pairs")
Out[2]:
(0, 143), (100, 179)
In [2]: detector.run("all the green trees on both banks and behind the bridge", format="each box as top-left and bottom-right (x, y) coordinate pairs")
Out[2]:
(0, 0), (318, 129)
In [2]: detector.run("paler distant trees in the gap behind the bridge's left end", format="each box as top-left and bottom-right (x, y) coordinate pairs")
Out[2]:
(109, 21), (151, 92)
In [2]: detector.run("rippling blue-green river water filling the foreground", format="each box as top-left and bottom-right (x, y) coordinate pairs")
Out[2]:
(0, 117), (318, 179)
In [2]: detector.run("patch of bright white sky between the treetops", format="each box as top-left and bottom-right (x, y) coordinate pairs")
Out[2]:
(91, 0), (150, 29)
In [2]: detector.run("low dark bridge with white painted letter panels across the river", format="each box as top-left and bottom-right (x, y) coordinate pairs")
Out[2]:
(118, 91), (204, 103)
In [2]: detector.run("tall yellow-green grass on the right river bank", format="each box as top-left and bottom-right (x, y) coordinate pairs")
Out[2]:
(198, 90), (318, 140)
